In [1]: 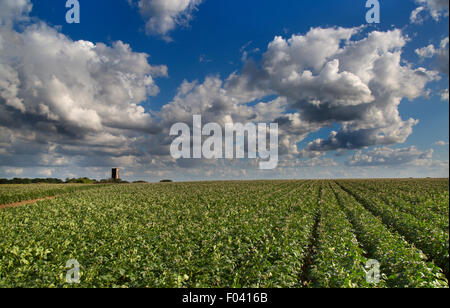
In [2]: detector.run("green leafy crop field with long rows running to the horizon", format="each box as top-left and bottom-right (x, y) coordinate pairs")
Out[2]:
(0, 179), (449, 288)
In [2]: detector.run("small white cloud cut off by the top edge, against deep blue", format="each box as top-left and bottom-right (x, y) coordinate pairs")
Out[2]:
(129, 0), (203, 40)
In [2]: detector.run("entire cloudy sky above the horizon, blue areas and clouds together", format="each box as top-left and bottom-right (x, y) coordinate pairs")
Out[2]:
(0, 0), (449, 181)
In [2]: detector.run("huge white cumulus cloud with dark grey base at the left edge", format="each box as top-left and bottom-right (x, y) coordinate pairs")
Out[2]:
(0, 1), (167, 172)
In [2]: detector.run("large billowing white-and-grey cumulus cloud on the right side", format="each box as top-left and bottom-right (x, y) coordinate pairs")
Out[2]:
(223, 28), (438, 153)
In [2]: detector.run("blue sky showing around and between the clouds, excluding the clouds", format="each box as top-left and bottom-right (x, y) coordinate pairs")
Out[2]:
(0, 0), (449, 180)
